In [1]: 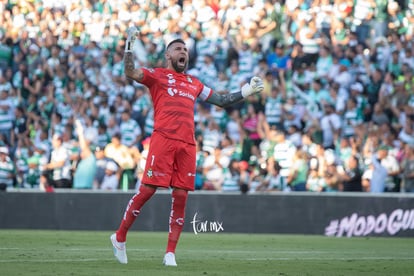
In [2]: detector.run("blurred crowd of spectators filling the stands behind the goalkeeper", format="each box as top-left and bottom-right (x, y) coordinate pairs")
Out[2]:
(0, 0), (414, 193)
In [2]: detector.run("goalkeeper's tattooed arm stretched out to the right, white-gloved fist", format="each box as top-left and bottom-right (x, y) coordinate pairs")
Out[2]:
(207, 77), (264, 108)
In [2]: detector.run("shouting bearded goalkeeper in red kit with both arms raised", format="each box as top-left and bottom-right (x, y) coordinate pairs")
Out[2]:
(111, 27), (263, 266)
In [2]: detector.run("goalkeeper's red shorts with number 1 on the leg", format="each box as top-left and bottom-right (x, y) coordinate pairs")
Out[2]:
(141, 132), (196, 191)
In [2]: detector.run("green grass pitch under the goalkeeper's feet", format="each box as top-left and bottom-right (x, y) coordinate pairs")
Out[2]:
(0, 230), (414, 276)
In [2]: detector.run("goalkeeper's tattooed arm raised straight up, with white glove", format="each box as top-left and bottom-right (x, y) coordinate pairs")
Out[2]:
(124, 27), (144, 82)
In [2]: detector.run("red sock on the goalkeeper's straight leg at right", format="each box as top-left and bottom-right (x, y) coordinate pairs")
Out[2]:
(166, 189), (188, 253)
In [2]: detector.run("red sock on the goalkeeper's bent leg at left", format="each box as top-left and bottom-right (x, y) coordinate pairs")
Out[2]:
(116, 184), (156, 242)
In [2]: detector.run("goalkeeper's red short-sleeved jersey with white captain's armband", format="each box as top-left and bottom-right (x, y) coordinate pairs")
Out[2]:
(141, 68), (212, 144)
